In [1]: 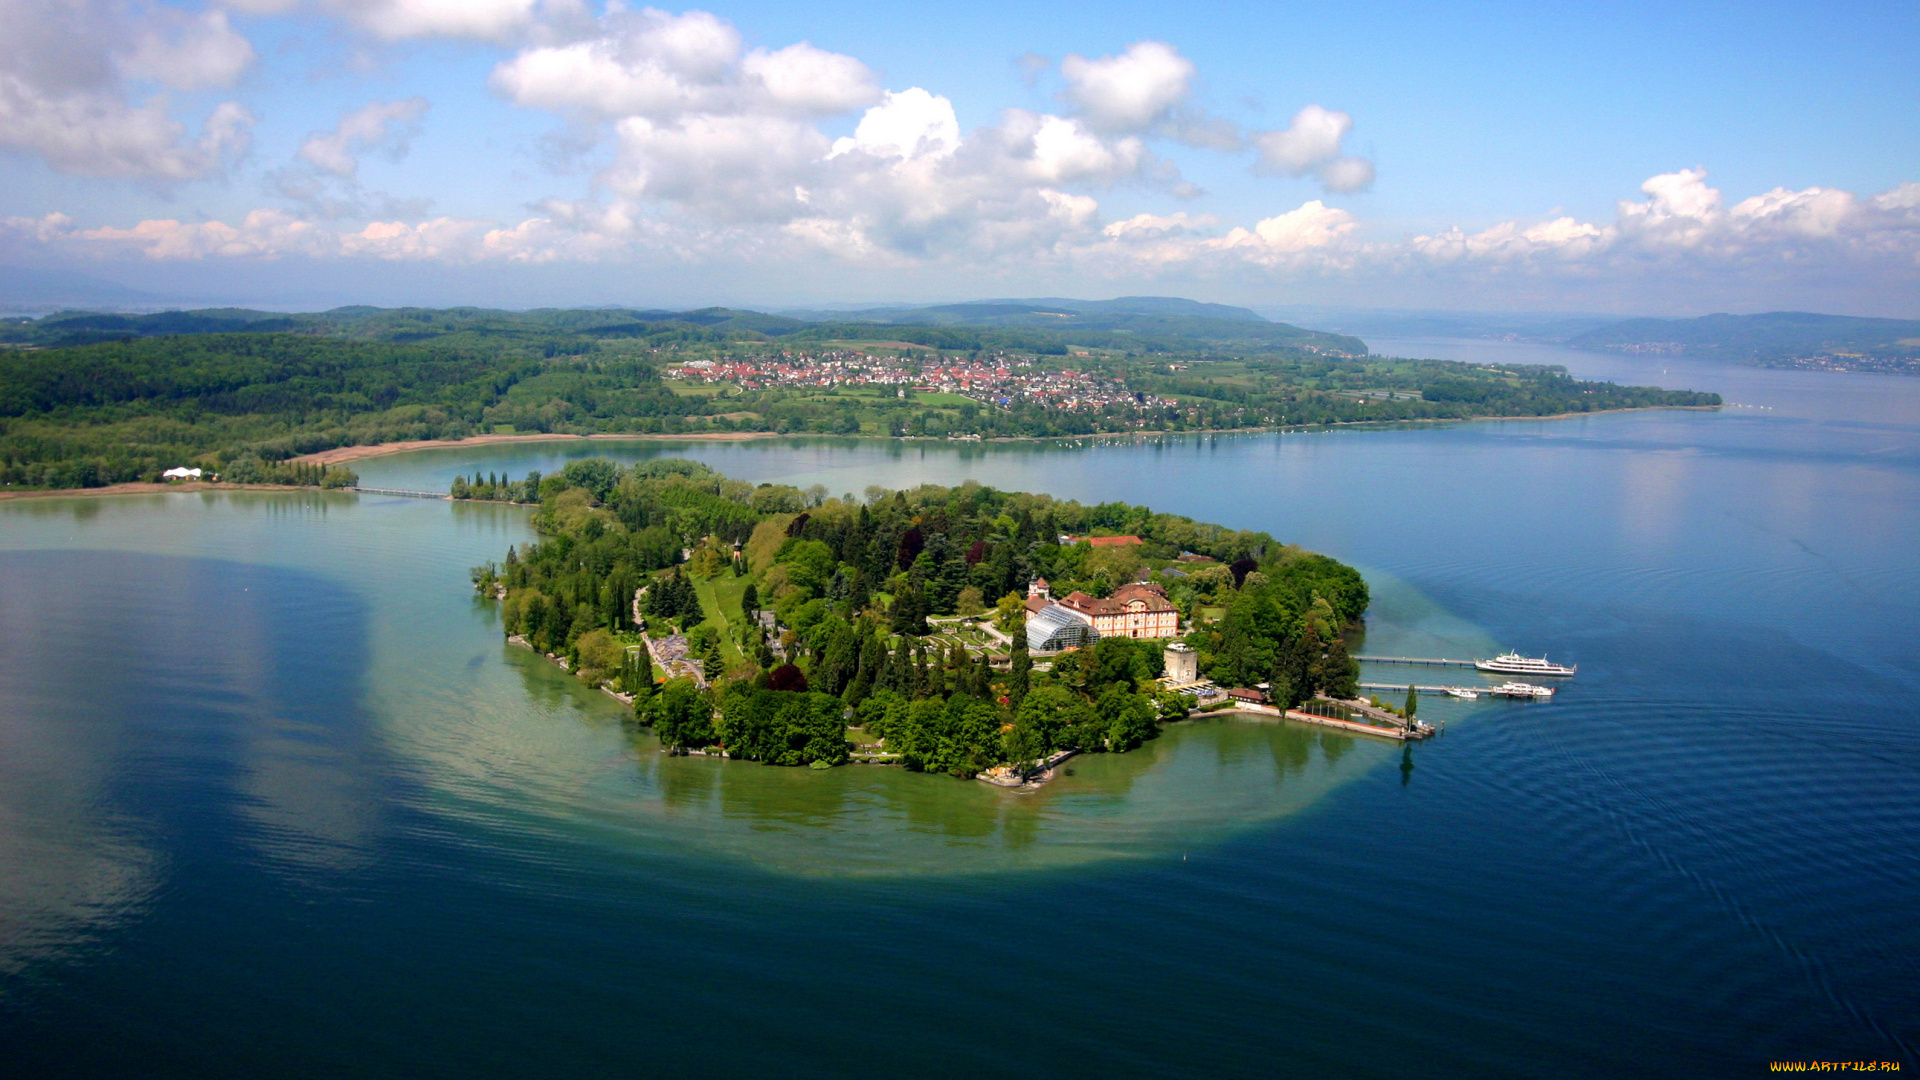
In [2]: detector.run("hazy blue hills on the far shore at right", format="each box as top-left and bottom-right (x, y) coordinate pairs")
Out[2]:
(1567, 311), (1920, 371)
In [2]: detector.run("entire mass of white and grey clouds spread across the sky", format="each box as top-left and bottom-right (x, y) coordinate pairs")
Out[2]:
(0, 0), (1920, 311)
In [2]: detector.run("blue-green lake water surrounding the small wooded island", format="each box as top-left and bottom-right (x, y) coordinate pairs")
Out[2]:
(0, 342), (1920, 1076)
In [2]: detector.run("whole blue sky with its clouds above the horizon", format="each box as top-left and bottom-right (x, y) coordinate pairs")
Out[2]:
(0, 0), (1920, 317)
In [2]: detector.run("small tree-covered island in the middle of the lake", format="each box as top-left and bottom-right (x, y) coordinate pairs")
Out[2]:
(478, 457), (1369, 776)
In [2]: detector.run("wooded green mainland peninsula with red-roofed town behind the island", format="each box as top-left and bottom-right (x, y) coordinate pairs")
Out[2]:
(0, 298), (1720, 488)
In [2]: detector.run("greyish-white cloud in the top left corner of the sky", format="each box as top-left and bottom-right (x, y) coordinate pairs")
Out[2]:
(0, 0), (253, 181)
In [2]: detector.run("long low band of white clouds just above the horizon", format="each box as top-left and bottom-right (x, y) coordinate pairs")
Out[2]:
(18, 167), (1920, 306)
